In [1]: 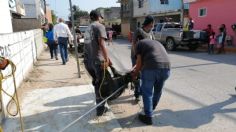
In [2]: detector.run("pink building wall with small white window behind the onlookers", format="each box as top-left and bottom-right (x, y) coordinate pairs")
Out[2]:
(189, 0), (236, 46)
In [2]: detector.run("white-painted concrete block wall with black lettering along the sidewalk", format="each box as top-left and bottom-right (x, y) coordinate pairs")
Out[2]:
(0, 29), (45, 116)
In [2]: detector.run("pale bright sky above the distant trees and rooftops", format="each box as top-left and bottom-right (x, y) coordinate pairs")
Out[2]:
(46, 0), (120, 20)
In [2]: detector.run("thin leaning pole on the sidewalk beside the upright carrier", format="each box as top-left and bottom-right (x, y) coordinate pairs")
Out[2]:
(69, 0), (81, 78)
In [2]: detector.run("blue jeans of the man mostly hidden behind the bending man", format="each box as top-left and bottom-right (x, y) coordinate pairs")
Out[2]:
(131, 51), (141, 98)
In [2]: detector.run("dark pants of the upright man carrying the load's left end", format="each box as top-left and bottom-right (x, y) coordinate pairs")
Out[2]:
(84, 59), (105, 109)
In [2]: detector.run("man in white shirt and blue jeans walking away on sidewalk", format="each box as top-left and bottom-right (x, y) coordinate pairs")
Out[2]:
(53, 18), (73, 65)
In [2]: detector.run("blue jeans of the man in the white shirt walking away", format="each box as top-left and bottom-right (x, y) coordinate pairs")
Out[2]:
(58, 37), (68, 64)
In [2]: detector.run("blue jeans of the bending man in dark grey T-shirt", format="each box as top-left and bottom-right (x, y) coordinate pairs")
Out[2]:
(141, 69), (170, 117)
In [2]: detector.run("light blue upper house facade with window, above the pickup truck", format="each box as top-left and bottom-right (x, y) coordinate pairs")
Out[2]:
(133, 0), (189, 30)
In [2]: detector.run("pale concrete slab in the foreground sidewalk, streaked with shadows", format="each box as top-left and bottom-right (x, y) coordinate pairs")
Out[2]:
(4, 93), (121, 132)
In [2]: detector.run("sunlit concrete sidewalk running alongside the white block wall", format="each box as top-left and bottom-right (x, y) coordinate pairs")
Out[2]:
(4, 48), (122, 132)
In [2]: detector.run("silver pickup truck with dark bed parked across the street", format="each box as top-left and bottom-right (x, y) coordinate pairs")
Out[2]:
(153, 22), (207, 50)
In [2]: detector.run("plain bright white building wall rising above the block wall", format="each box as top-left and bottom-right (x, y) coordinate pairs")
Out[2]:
(0, 0), (13, 33)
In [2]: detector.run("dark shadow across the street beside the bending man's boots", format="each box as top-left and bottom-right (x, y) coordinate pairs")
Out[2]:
(110, 90), (236, 129)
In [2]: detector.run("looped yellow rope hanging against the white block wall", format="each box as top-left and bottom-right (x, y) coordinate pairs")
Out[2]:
(0, 60), (24, 132)
